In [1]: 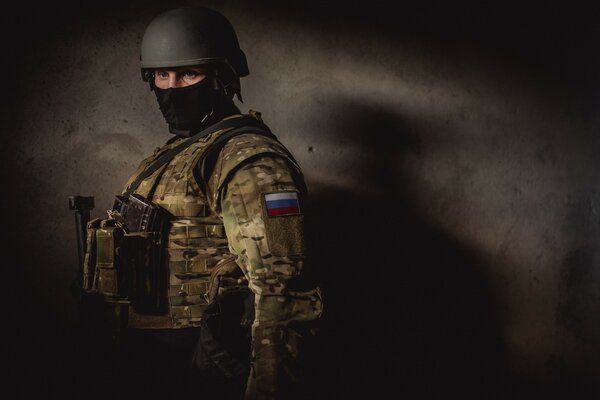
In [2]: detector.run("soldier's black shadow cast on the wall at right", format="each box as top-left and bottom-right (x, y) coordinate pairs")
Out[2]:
(309, 98), (508, 399)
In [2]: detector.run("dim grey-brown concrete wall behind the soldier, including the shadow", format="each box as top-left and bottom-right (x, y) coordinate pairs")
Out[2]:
(2, 1), (600, 398)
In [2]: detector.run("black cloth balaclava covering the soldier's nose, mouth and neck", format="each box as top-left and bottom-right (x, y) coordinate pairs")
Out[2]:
(150, 76), (239, 136)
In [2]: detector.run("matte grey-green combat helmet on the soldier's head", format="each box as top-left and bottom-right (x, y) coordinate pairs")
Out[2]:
(140, 6), (249, 81)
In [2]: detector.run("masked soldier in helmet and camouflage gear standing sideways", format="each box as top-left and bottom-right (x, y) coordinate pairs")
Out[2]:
(84, 7), (322, 399)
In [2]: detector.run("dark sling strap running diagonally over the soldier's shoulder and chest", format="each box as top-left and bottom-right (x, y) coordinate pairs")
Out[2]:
(123, 115), (272, 196)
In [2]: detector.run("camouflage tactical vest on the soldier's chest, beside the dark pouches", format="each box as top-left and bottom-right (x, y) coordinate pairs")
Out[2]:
(119, 134), (225, 328)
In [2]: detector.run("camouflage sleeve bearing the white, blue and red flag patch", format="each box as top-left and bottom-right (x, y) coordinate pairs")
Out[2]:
(215, 137), (322, 400)
